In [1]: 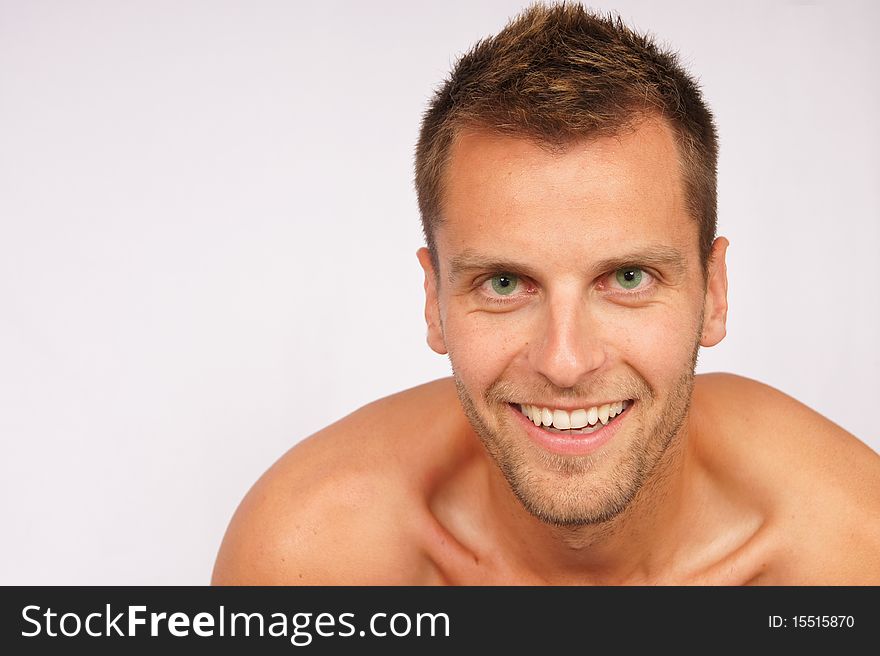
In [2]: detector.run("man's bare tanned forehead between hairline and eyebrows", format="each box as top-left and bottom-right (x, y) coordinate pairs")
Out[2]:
(435, 119), (698, 270)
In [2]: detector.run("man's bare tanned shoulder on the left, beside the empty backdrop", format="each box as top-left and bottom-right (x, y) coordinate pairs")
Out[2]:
(212, 381), (468, 585)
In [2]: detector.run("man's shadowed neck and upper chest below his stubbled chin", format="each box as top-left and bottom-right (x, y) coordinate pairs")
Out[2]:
(489, 421), (695, 584)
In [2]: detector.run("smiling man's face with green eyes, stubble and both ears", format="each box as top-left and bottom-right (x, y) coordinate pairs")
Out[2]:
(419, 121), (726, 525)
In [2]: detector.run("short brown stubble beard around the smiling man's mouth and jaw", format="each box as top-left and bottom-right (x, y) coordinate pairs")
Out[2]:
(453, 344), (699, 527)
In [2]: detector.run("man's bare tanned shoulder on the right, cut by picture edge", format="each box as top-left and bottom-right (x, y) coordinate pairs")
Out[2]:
(693, 374), (880, 585)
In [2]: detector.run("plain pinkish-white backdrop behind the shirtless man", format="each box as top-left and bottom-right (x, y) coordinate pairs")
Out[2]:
(0, 0), (880, 585)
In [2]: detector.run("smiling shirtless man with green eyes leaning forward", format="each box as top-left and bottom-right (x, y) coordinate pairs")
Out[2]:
(214, 5), (880, 584)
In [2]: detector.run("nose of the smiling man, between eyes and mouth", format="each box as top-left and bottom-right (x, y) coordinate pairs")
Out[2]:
(529, 296), (607, 388)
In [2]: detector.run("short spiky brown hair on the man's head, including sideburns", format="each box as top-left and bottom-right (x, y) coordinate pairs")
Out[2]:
(415, 4), (718, 269)
